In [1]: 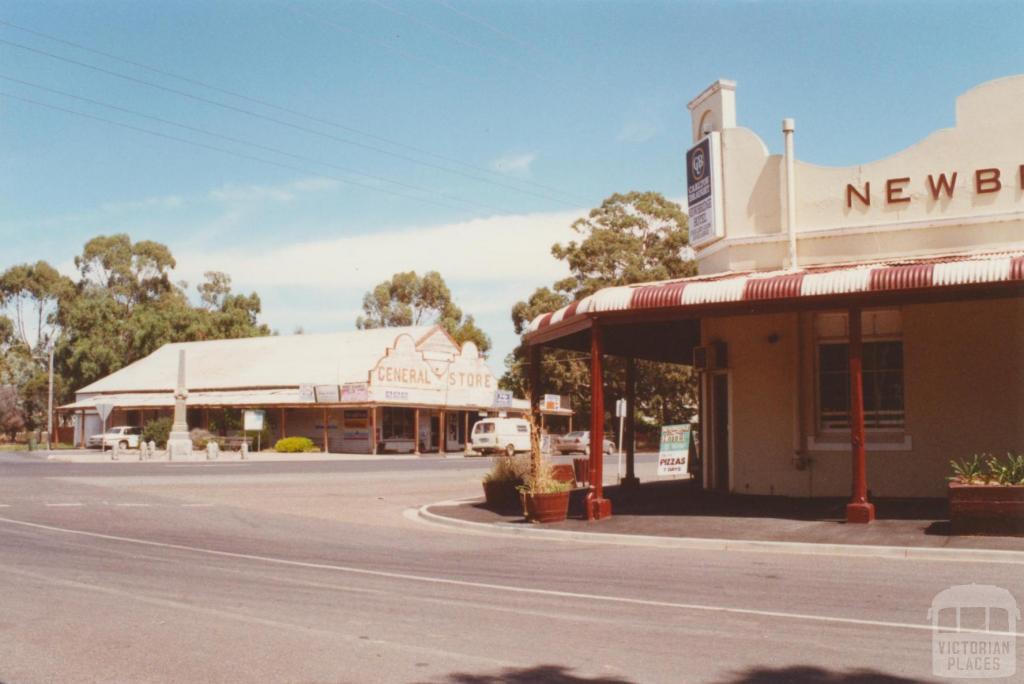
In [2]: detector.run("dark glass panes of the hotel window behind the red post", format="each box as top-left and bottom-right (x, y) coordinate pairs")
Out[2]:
(818, 340), (903, 429)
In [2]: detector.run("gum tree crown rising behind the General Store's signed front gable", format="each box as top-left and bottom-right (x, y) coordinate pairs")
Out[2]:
(355, 270), (490, 353)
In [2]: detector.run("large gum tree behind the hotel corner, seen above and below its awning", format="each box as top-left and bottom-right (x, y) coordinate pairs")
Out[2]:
(501, 191), (696, 425)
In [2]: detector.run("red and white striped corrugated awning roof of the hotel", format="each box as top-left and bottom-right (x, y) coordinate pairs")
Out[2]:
(526, 251), (1024, 338)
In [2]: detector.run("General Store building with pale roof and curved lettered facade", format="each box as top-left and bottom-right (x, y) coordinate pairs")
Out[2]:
(60, 326), (568, 454)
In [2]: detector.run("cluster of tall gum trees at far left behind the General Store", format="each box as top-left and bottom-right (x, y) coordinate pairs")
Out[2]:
(0, 233), (270, 428)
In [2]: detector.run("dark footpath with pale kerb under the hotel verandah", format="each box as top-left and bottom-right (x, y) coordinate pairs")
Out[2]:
(418, 480), (1024, 564)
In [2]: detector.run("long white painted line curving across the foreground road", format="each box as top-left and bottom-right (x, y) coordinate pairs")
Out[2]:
(0, 517), (1024, 639)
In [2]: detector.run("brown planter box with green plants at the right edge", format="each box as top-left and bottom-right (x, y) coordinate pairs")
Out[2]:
(948, 454), (1024, 537)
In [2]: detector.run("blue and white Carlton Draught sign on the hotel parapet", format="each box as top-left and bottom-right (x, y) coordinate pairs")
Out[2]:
(686, 132), (724, 247)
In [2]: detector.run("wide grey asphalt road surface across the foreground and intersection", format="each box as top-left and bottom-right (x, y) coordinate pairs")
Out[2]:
(0, 455), (1024, 684)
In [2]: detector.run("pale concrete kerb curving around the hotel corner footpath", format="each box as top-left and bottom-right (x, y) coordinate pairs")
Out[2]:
(416, 499), (1024, 565)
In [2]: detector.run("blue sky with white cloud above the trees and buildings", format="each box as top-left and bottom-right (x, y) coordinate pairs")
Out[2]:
(0, 0), (1024, 372)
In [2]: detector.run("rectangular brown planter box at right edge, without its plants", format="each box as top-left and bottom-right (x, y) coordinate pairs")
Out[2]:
(949, 482), (1024, 537)
